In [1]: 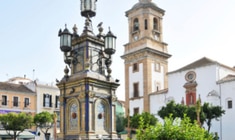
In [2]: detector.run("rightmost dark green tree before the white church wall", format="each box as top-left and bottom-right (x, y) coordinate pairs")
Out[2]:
(202, 103), (225, 132)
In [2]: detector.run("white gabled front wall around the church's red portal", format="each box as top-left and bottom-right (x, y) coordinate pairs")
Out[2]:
(167, 65), (219, 103)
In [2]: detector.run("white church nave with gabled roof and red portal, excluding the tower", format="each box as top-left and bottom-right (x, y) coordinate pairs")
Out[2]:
(149, 57), (235, 140)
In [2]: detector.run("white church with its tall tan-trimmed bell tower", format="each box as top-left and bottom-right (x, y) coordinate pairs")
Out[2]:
(121, 0), (235, 140)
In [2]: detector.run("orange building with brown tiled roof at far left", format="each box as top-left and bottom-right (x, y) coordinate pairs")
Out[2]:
(0, 82), (37, 115)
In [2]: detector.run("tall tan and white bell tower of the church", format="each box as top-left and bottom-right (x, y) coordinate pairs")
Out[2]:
(121, 0), (171, 116)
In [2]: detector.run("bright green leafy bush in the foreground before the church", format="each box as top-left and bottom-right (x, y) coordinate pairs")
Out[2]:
(137, 116), (213, 140)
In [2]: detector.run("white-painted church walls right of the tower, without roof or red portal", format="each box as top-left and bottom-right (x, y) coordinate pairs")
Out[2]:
(150, 64), (235, 140)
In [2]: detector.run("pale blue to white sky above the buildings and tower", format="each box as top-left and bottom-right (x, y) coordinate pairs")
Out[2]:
(0, 0), (235, 100)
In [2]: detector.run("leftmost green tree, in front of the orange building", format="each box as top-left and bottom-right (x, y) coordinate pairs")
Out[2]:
(0, 113), (33, 140)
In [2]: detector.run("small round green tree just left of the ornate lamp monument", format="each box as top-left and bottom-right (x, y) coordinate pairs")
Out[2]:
(33, 111), (54, 140)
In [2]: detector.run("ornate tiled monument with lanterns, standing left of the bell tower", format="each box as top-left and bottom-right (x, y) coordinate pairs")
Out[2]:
(57, 0), (119, 139)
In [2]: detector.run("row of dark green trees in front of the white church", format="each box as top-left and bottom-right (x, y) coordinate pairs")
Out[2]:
(158, 101), (225, 132)
